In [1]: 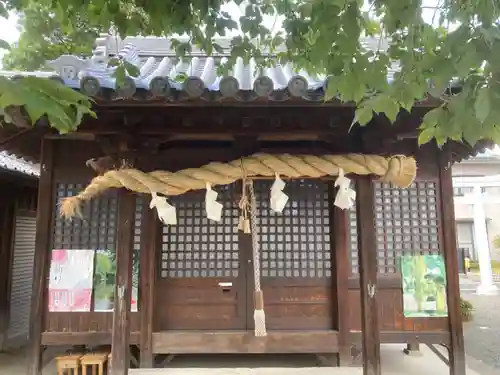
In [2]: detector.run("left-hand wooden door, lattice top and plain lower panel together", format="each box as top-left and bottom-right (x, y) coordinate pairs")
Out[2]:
(155, 185), (246, 330)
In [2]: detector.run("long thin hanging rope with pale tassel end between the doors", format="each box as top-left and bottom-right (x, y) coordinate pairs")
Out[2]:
(248, 181), (267, 336)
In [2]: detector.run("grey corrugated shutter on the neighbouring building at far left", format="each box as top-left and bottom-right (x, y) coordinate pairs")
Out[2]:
(5, 215), (36, 347)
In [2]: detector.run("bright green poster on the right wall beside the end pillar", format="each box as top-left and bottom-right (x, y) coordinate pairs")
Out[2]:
(400, 255), (448, 318)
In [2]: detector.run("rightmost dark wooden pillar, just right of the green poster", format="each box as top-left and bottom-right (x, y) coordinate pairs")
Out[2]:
(439, 152), (466, 375)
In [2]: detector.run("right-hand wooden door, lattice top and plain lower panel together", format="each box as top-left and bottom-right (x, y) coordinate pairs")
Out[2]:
(256, 180), (334, 330)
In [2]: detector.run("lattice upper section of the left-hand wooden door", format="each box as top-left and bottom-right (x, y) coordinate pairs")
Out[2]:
(161, 185), (239, 277)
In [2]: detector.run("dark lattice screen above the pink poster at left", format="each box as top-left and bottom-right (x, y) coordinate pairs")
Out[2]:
(52, 183), (118, 249)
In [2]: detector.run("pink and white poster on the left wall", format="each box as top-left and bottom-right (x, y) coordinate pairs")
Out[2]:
(49, 250), (94, 312)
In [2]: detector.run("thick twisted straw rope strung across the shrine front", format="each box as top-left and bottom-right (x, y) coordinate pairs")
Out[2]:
(60, 153), (417, 218)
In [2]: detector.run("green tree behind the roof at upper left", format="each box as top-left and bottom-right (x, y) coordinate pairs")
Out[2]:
(3, 2), (101, 71)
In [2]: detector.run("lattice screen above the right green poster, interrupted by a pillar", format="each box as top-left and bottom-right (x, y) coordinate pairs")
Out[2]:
(349, 181), (440, 273)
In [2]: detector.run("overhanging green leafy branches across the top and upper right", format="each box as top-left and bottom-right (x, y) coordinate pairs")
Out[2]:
(0, 0), (500, 145)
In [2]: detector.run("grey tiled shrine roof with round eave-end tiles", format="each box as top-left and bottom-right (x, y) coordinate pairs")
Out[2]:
(0, 36), (410, 101)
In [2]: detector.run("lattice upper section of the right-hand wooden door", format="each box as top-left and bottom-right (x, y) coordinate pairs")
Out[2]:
(255, 180), (331, 277)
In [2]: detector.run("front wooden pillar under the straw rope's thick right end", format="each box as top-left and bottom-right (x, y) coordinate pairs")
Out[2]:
(356, 176), (381, 375)
